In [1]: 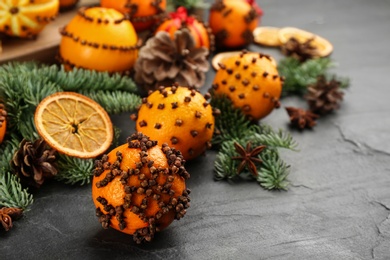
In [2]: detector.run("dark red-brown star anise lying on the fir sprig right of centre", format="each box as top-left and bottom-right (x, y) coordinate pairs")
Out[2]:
(232, 142), (265, 177)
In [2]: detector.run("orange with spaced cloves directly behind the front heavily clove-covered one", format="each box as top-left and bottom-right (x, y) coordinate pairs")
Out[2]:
(136, 86), (214, 160)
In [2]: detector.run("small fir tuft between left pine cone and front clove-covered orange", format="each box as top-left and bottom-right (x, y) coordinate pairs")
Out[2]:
(55, 154), (94, 185)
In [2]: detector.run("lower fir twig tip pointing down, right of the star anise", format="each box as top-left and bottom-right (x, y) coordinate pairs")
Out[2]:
(256, 149), (290, 190)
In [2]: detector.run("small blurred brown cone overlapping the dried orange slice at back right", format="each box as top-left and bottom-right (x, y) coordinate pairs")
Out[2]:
(282, 37), (318, 62)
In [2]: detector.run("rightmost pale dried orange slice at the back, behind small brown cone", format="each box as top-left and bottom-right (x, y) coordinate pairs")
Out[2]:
(279, 27), (333, 57)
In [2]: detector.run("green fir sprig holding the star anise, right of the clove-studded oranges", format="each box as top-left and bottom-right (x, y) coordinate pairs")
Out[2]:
(211, 95), (297, 190)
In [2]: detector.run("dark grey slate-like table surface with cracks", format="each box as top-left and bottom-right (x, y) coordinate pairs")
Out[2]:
(0, 0), (390, 259)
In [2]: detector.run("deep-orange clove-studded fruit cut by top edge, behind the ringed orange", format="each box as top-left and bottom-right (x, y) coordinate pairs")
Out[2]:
(100, 0), (167, 32)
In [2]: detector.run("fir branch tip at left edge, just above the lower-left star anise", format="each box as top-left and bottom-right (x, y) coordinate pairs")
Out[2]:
(0, 172), (33, 210)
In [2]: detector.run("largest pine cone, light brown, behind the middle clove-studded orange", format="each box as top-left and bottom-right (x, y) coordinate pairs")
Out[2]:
(134, 29), (209, 91)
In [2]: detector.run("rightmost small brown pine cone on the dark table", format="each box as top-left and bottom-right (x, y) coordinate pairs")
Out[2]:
(305, 76), (344, 115)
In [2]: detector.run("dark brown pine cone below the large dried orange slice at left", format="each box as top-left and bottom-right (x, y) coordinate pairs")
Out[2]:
(11, 139), (57, 188)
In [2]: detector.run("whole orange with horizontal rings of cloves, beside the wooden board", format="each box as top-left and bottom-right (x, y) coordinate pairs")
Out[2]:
(60, 7), (138, 73)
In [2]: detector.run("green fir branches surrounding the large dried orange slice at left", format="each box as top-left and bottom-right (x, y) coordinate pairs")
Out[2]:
(0, 62), (141, 208)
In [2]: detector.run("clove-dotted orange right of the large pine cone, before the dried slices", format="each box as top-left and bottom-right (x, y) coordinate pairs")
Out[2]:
(212, 52), (283, 120)
